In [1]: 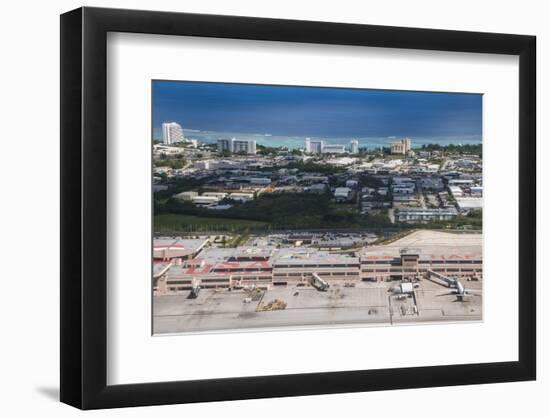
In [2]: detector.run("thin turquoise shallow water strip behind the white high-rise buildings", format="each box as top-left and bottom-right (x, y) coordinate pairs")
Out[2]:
(153, 128), (482, 150)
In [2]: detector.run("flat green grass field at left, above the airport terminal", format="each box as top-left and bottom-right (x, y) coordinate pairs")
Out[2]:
(154, 214), (267, 232)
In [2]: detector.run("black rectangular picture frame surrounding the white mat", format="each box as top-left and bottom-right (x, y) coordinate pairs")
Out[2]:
(60, 7), (536, 409)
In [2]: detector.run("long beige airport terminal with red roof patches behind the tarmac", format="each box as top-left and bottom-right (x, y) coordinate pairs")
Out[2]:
(153, 232), (483, 295)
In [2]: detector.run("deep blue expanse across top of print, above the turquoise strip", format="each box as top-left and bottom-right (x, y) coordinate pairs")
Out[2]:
(153, 81), (482, 137)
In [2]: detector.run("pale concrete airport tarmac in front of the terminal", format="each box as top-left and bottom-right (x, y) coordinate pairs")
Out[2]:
(153, 280), (482, 334)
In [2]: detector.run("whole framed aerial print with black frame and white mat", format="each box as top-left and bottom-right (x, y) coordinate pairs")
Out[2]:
(61, 8), (536, 409)
